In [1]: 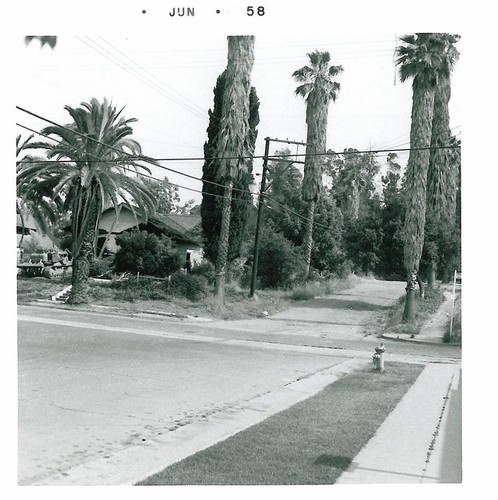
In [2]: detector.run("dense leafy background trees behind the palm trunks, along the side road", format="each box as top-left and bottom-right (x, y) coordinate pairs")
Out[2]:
(201, 140), (460, 287)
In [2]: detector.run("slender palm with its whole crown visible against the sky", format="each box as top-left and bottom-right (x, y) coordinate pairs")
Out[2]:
(292, 51), (343, 274)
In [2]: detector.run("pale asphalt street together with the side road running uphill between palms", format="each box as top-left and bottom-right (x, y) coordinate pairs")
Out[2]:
(18, 280), (461, 485)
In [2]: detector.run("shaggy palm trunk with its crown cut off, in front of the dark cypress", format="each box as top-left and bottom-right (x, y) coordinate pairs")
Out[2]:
(215, 36), (254, 304)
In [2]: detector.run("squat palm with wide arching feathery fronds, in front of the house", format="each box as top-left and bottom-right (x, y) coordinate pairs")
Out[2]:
(17, 98), (155, 303)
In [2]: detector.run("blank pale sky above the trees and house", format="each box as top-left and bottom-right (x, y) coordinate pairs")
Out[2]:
(13, 9), (462, 202)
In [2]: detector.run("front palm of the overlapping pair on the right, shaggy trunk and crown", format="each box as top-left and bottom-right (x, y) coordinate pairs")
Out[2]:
(396, 33), (462, 322)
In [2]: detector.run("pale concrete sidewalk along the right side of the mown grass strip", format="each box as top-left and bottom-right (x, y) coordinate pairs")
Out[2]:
(336, 364), (462, 484)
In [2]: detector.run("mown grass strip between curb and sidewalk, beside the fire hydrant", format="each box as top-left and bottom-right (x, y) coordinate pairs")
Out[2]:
(138, 363), (423, 485)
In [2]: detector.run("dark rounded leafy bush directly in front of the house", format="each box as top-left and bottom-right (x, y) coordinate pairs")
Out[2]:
(114, 230), (182, 277)
